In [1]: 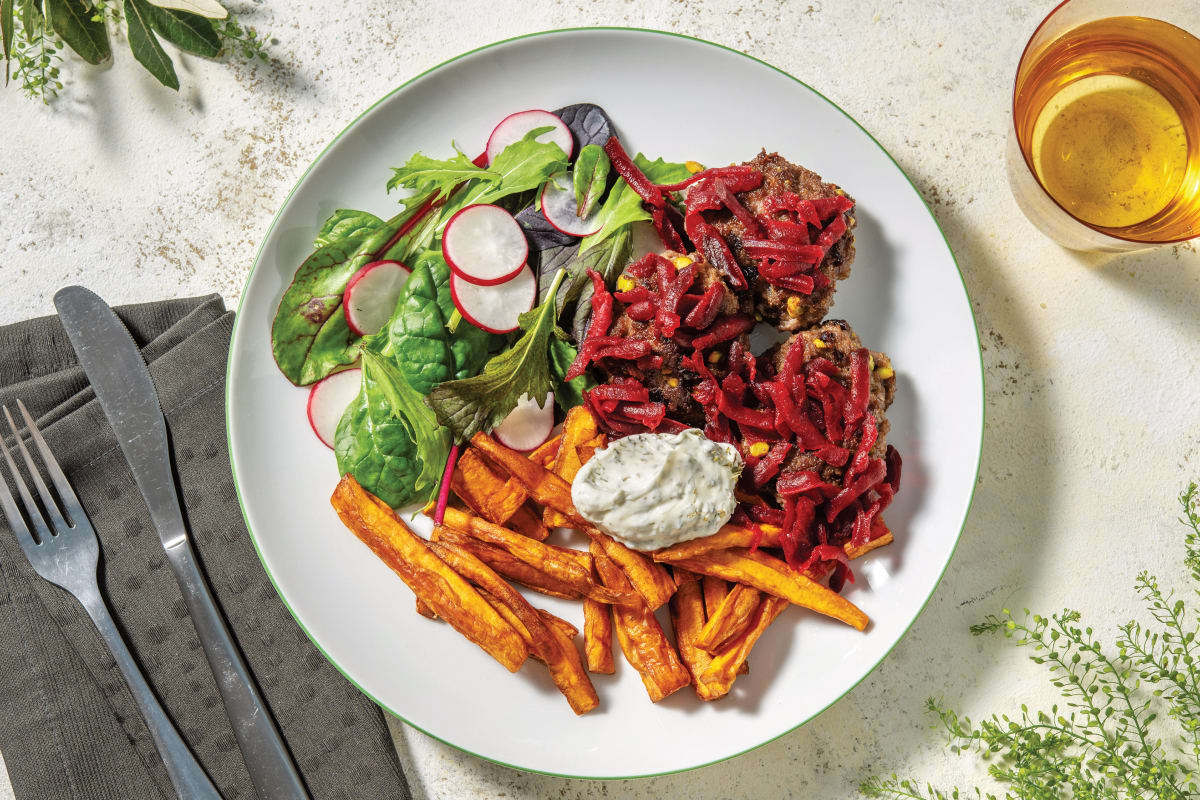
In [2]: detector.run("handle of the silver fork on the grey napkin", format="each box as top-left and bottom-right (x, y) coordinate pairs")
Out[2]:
(84, 594), (221, 800)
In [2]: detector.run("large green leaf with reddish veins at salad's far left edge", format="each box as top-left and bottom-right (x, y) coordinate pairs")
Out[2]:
(271, 200), (432, 385)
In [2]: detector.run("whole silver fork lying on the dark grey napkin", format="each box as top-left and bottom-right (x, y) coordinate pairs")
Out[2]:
(0, 401), (221, 800)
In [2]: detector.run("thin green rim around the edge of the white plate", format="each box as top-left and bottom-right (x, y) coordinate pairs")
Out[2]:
(226, 25), (988, 781)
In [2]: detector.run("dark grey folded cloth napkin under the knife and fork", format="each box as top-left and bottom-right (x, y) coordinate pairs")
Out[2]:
(0, 296), (410, 800)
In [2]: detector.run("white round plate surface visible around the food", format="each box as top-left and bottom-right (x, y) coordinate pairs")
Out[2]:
(228, 29), (983, 778)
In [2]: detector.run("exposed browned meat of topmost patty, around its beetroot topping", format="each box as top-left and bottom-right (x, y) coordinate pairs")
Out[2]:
(704, 150), (856, 331)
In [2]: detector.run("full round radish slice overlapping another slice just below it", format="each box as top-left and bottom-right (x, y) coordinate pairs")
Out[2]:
(442, 205), (529, 287)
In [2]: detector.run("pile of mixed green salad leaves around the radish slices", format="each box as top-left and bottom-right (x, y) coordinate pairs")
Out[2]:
(271, 103), (689, 507)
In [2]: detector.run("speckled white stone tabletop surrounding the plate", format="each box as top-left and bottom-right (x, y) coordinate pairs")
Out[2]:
(0, 0), (1200, 800)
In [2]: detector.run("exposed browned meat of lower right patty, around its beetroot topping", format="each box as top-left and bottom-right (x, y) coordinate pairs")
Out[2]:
(758, 319), (896, 494)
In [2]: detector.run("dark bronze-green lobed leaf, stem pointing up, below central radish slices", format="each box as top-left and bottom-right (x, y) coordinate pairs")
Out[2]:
(428, 271), (566, 444)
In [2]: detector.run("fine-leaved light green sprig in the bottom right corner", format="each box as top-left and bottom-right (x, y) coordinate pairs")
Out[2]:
(860, 483), (1200, 800)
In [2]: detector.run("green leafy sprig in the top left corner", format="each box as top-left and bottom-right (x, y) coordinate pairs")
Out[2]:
(0, 0), (268, 104)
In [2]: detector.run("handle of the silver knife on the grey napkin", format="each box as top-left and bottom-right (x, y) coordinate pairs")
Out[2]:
(166, 536), (308, 800)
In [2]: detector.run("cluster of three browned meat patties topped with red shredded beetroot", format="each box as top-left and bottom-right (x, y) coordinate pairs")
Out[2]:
(572, 152), (900, 566)
